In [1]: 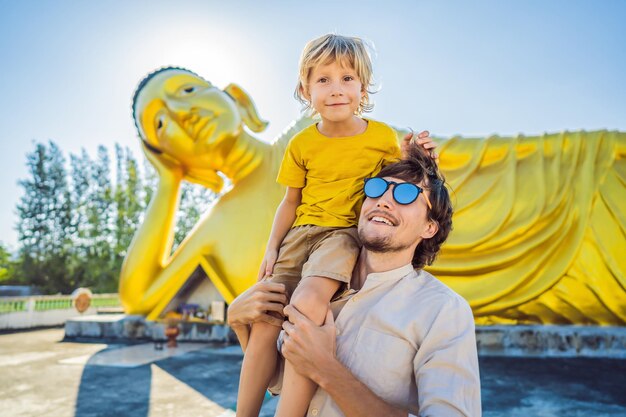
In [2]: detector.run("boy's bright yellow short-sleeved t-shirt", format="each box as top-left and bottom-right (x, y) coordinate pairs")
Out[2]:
(277, 120), (400, 227)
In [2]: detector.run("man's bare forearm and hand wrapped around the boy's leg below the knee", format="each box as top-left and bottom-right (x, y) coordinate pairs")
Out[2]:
(282, 305), (408, 417)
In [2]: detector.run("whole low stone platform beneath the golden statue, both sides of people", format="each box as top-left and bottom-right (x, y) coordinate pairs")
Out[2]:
(65, 314), (626, 358)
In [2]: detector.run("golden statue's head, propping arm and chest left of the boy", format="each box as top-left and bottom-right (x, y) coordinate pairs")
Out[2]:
(119, 68), (310, 319)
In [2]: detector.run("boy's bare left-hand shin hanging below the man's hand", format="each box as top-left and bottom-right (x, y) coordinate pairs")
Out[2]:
(237, 322), (281, 417)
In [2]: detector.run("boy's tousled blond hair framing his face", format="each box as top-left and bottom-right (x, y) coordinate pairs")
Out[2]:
(294, 33), (374, 114)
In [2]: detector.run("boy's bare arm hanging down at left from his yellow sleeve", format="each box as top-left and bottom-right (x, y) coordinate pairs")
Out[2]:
(258, 187), (302, 280)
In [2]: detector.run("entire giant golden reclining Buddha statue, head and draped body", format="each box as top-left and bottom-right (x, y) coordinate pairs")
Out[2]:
(119, 68), (626, 325)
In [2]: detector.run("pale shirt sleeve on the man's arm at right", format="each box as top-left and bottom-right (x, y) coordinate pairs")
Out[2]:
(413, 298), (481, 417)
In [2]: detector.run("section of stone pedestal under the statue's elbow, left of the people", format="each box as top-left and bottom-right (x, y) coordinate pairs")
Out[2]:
(65, 314), (236, 343)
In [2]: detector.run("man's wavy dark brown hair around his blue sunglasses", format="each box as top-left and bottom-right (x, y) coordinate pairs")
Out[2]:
(377, 145), (452, 269)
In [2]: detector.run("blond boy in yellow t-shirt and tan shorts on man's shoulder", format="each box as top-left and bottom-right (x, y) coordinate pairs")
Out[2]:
(237, 34), (435, 417)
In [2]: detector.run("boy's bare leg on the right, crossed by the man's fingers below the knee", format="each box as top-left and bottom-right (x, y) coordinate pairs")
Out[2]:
(275, 277), (341, 417)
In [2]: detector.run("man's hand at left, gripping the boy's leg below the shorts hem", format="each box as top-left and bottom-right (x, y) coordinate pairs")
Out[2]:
(228, 281), (287, 327)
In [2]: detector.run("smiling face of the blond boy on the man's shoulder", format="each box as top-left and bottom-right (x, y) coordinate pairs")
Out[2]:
(304, 61), (364, 123)
